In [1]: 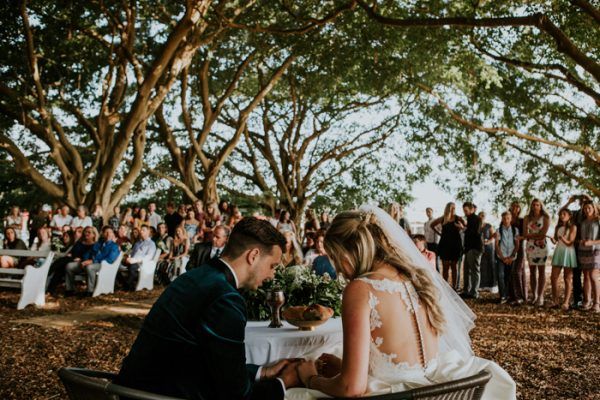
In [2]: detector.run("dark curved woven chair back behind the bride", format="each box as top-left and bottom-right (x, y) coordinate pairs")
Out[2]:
(324, 370), (492, 400)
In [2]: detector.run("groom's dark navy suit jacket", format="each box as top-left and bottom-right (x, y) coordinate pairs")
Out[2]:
(116, 259), (284, 400)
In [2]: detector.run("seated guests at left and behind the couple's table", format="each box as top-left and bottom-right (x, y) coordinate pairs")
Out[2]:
(0, 200), (344, 297)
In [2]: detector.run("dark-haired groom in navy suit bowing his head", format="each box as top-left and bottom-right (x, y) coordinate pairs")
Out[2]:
(116, 218), (299, 400)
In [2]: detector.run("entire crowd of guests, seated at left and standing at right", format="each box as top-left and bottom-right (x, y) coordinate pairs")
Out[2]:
(0, 195), (600, 312)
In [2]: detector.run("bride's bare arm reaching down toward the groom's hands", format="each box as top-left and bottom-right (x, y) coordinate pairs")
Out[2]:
(299, 281), (371, 397)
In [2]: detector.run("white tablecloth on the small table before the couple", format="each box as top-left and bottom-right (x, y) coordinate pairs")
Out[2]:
(245, 318), (342, 365)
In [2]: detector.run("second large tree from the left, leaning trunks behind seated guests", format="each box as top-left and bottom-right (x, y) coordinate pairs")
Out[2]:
(149, 1), (360, 202)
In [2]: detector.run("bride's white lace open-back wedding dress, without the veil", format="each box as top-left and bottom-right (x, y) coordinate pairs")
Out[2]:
(286, 277), (516, 400)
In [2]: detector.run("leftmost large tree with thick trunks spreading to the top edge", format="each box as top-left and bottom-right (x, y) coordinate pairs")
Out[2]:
(0, 0), (252, 216)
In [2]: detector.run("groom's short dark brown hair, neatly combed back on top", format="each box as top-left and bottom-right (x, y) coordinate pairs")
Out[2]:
(223, 217), (286, 259)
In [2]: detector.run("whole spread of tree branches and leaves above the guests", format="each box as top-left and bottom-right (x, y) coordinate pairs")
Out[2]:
(0, 0), (600, 216)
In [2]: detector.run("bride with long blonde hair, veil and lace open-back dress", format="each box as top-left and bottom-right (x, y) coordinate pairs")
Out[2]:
(286, 206), (516, 400)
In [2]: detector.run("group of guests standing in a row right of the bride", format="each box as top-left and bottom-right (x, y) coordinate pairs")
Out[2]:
(418, 195), (600, 312)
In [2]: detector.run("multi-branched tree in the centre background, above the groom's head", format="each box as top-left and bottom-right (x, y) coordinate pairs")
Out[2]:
(222, 74), (408, 222)
